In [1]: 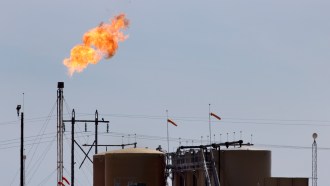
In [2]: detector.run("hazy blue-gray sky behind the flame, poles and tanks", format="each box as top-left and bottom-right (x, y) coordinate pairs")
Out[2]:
(0, 0), (330, 186)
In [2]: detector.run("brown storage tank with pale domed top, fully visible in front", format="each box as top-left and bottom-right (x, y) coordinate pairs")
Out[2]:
(105, 148), (165, 186)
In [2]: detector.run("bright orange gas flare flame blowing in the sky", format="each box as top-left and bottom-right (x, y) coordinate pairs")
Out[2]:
(63, 14), (129, 76)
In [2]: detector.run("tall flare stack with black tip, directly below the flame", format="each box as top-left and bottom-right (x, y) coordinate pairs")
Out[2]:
(57, 82), (64, 186)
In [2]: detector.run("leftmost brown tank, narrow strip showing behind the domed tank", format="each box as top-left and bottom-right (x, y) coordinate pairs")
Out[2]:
(93, 153), (105, 186)
